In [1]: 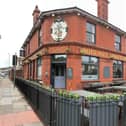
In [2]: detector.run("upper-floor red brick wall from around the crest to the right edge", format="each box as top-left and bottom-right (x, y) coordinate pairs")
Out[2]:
(43, 14), (126, 52)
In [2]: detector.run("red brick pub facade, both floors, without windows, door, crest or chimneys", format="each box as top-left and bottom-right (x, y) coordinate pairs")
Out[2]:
(23, 2), (126, 90)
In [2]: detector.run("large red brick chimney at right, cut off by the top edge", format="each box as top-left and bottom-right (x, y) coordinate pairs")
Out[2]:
(96, 0), (109, 21)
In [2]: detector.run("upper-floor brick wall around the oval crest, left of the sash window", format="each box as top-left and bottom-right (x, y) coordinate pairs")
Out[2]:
(43, 14), (85, 44)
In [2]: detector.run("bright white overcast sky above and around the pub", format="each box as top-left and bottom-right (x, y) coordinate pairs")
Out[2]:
(0, 0), (126, 68)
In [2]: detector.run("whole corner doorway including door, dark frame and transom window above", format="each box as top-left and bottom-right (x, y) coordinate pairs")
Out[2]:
(51, 55), (66, 88)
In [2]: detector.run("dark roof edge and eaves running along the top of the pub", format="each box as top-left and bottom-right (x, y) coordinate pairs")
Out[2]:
(22, 7), (126, 47)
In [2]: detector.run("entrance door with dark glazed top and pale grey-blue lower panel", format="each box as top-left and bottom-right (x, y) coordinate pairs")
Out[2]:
(54, 64), (66, 88)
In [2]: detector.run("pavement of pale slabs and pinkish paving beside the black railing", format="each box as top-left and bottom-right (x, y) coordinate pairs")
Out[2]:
(0, 78), (44, 126)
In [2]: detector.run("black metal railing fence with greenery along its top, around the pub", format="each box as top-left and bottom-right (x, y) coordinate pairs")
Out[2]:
(15, 78), (126, 126)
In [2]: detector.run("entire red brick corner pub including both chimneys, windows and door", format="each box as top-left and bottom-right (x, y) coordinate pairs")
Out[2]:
(22, 0), (126, 90)
